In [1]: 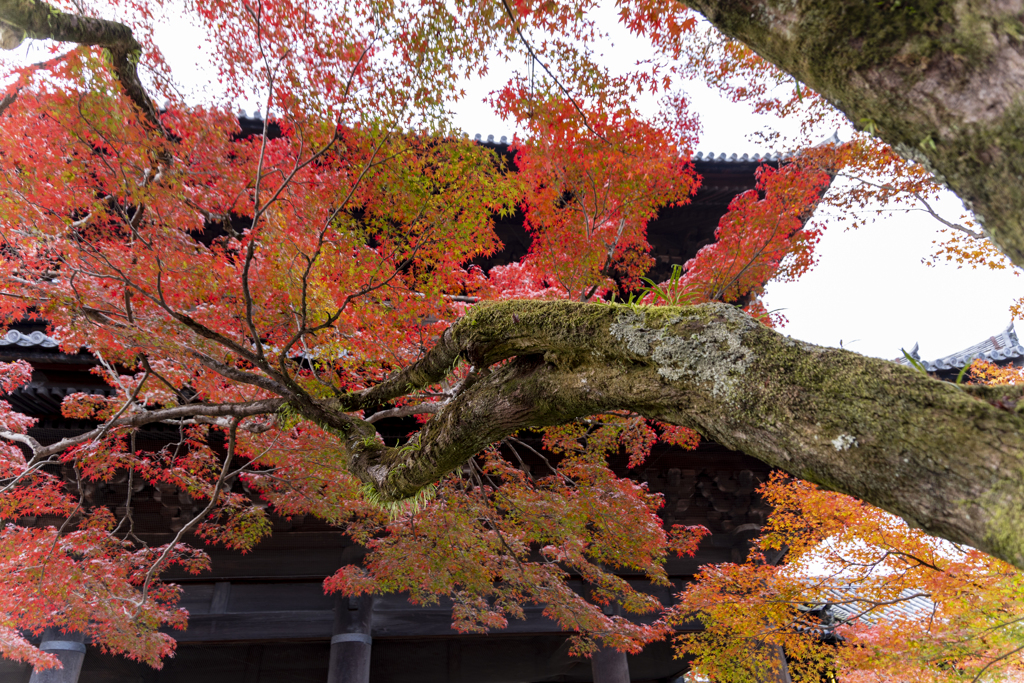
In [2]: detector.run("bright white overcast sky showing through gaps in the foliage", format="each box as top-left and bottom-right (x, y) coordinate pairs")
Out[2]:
(8, 7), (1024, 359)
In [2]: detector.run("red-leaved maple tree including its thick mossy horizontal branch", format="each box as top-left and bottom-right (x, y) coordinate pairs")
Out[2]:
(0, 0), (1024, 679)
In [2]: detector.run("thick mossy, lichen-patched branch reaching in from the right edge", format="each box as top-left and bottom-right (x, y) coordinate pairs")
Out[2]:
(348, 301), (1024, 567)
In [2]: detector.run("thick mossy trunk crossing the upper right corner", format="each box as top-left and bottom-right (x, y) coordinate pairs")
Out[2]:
(687, 0), (1024, 265)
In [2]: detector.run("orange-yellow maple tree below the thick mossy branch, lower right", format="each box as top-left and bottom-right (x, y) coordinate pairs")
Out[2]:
(665, 359), (1024, 683)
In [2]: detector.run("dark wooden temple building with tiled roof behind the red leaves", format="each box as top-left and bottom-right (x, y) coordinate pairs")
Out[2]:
(0, 136), (790, 683)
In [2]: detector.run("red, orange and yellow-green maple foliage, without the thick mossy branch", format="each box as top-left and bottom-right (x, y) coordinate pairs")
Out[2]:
(0, 0), (1016, 680)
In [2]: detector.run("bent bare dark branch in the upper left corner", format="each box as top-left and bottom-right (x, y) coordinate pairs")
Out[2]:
(0, 0), (166, 135)
